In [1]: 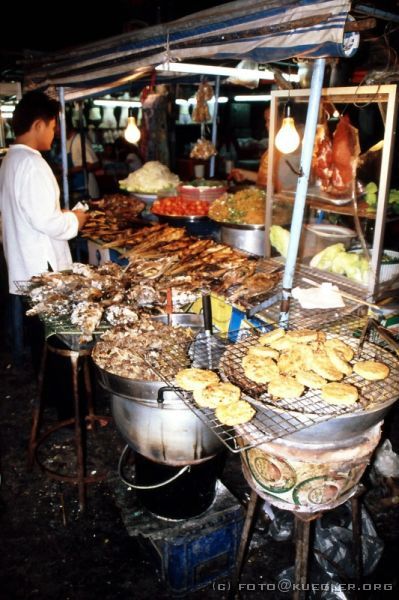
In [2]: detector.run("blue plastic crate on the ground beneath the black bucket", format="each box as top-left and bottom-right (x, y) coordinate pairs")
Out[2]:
(148, 482), (244, 596)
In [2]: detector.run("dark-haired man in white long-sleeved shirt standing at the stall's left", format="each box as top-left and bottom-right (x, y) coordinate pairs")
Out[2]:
(0, 91), (87, 362)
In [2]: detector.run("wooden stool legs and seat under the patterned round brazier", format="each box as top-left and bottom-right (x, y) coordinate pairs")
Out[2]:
(229, 484), (364, 600)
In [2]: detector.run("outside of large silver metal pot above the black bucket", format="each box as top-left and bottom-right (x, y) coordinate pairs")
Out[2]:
(98, 369), (223, 466)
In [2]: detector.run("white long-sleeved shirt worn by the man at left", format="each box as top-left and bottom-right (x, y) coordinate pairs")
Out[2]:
(0, 144), (79, 294)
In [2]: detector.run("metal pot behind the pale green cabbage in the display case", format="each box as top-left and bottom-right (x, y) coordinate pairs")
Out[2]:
(299, 223), (356, 258)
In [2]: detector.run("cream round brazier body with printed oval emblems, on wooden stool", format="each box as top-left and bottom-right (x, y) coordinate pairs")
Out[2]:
(241, 423), (382, 513)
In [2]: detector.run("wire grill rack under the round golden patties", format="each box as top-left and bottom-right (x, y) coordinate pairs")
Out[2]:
(138, 318), (399, 452)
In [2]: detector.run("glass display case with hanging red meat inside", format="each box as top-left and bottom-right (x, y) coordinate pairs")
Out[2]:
(265, 85), (399, 300)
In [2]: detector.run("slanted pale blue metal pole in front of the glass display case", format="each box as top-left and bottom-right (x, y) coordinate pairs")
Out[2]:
(280, 58), (326, 327)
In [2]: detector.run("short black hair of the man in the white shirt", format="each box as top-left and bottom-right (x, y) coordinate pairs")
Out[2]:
(12, 90), (60, 136)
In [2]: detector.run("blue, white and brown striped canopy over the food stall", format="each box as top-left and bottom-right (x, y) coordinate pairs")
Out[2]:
(25, 0), (351, 99)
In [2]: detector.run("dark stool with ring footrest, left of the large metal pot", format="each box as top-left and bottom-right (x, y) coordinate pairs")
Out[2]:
(28, 341), (111, 511)
